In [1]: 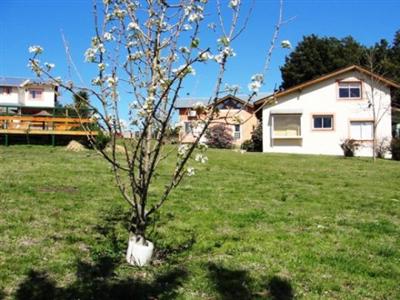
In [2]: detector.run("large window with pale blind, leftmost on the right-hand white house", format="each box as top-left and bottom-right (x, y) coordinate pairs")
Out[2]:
(272, 114), (301, 138)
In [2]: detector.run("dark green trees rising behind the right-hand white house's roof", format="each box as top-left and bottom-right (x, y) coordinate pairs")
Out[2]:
(281, 30), (400, 107)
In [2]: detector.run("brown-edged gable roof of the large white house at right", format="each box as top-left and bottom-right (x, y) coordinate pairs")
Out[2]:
(255, 65), (400, 105)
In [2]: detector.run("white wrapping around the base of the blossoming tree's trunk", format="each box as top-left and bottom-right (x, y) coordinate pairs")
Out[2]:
(126, 235), (154, 267)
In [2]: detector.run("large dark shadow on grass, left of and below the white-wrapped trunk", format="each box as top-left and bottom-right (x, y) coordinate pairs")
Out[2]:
(15, 205), (191, 300)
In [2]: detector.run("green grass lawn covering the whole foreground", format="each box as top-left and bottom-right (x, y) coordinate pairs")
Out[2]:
(0, 146), (400, 299)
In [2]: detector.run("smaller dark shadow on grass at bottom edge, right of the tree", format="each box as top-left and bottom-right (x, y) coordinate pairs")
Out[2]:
(208, 263), (294, 300)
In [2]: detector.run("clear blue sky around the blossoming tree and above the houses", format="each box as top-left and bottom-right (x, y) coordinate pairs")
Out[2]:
(0, 0), (400, 109)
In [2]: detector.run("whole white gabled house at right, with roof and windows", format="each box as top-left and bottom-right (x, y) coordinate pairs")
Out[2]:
(256, 66), (400, 156)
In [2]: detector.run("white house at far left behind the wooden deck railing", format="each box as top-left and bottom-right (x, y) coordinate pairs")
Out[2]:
(0, 76), (57, 108)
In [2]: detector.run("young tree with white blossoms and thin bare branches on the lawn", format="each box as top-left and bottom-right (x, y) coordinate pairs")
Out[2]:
(29, 0), (287, 266)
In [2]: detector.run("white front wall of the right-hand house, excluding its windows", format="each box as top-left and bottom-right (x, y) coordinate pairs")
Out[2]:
(263, 72), (392, 156)
